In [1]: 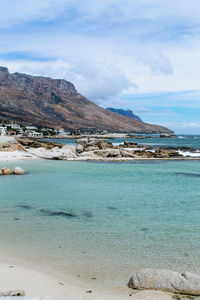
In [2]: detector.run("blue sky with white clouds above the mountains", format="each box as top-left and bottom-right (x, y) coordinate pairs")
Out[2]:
(0, 0), (200, 134)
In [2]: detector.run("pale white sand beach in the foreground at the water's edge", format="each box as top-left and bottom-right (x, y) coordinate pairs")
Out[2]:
(0, 264), (172, 300)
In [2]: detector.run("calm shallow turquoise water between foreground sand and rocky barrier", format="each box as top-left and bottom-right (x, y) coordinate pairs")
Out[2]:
(0, 160), (200, 286)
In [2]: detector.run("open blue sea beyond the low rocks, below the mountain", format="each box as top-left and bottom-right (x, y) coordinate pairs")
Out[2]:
(45, 135), (200, 150)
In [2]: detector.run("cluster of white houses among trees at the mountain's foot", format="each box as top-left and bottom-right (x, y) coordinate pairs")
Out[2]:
(0, 121), (70, 138)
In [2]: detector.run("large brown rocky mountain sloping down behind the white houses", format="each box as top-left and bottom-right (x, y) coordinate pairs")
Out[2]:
(0, 67), (171, 133)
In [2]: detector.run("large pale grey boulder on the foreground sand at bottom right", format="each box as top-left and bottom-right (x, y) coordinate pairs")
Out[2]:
(128, 269), (200, 296)
